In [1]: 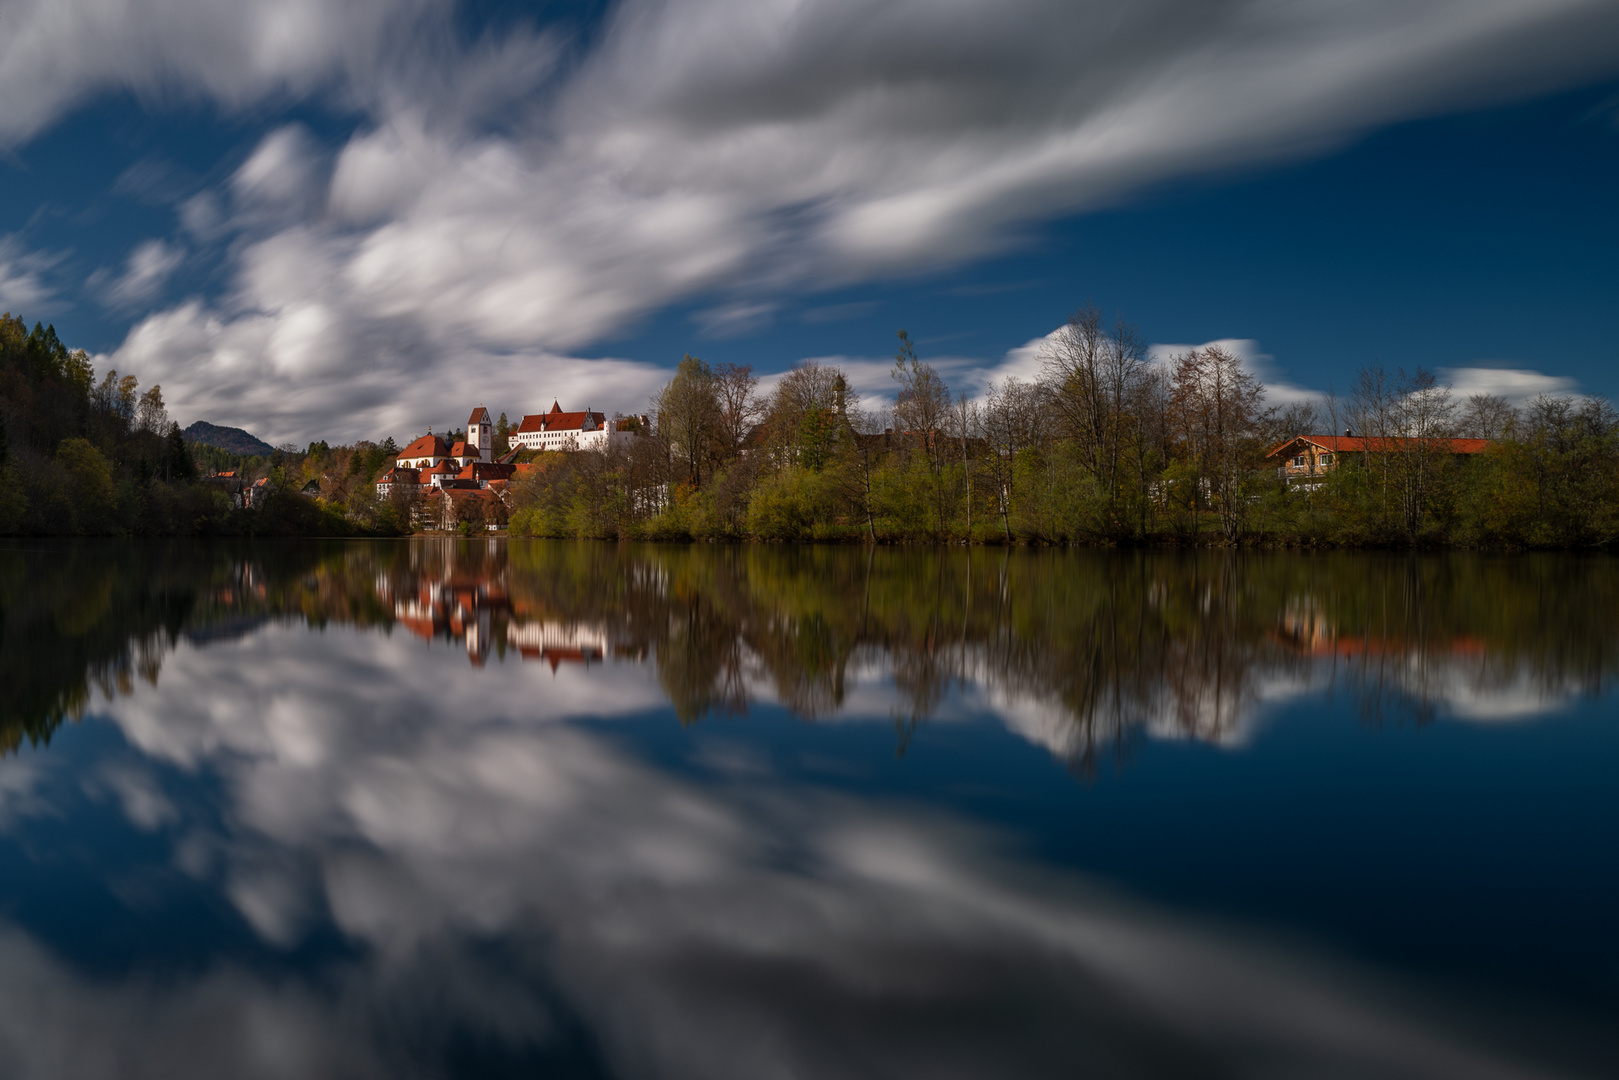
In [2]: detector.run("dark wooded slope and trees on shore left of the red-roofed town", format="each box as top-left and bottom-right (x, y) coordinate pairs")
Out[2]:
(0, 314), (408, 536)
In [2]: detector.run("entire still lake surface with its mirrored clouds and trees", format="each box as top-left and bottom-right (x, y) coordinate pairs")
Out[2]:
(0, 541), (1619, 1080)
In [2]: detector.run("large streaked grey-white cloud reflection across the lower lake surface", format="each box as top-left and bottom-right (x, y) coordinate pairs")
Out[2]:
(38, 628), (1593, 1078)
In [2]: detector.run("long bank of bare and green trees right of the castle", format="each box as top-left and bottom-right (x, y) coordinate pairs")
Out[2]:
(510, 308), (1619, 547)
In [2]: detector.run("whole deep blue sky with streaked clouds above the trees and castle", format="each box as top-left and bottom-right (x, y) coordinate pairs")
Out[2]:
(0, 0), (1619, 444)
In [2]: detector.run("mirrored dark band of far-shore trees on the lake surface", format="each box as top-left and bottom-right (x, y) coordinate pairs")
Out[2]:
(0, 539), (1619, 769)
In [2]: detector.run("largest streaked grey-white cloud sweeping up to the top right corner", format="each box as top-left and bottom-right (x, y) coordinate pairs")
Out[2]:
(59, 0), (1619, 437)
